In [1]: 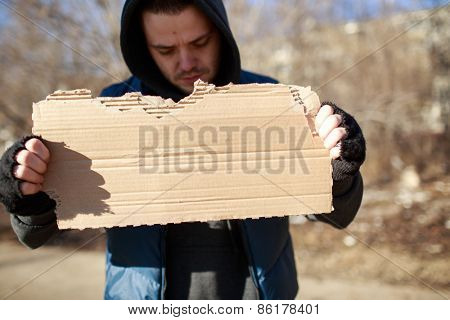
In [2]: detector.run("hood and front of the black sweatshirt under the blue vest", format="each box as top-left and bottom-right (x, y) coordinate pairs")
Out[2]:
(120, 0), (273, 299)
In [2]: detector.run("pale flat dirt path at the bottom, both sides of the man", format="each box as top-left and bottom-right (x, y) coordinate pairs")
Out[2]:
(0, 242), (450, 299)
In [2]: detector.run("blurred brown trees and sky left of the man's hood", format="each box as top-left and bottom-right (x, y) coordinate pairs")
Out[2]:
(0, 0), (128, 136)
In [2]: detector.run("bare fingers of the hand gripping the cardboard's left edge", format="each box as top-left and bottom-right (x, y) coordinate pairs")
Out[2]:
(13, 138), (50, 196)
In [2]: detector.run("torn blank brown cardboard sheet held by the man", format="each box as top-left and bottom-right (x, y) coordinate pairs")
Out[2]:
(33, 81), (332, 229)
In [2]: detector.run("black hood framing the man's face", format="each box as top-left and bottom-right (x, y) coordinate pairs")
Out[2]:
(120, 0), (241, 101)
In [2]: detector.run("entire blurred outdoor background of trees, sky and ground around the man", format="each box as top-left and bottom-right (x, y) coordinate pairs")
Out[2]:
(0, 0), (450, 299)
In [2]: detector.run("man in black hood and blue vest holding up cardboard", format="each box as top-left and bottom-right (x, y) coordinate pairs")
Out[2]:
(0, 0), (365, 299)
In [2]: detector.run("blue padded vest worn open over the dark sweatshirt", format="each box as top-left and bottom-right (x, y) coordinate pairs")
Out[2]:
(101, 71), (298, 300)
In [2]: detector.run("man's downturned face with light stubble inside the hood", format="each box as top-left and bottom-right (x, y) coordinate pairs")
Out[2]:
(142, 5), (220, 94)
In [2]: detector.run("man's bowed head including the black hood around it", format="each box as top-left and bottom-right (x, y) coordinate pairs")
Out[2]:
(120, 0), (241, 101)
